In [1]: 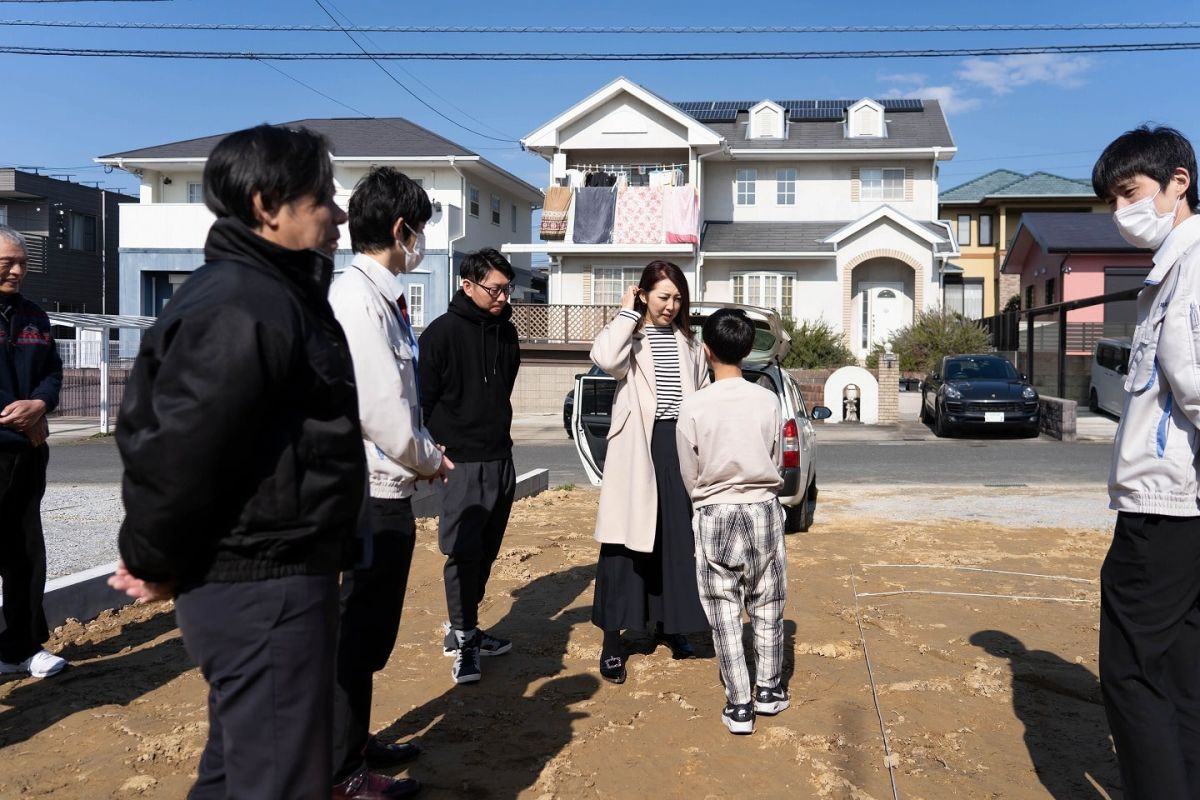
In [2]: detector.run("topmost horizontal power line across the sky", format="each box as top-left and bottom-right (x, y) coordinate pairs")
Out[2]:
(0, 19), (1200, 35)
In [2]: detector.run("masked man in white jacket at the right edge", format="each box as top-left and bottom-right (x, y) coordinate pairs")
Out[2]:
(1092, 126), (1200, 800)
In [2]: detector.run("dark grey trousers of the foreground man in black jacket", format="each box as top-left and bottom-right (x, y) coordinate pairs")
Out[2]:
(175, 575), (337, 800)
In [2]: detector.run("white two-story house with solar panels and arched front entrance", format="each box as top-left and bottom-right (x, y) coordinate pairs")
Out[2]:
(505, 78), (959, 355)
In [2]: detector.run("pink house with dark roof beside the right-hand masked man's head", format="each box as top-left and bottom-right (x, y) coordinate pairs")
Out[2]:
(1000, 212), (1153, 350)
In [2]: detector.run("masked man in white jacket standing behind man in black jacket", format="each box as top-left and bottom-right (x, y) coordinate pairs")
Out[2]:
(329, 167), (454, 800)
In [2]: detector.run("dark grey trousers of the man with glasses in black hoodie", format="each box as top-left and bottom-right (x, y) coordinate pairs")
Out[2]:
(438, 458), (517, 631)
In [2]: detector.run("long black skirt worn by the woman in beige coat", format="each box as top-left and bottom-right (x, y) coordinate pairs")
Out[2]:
(592, 420), (708, 633)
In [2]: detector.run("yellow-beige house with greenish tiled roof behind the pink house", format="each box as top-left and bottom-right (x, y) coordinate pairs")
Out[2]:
(938, 169), (1108, 318)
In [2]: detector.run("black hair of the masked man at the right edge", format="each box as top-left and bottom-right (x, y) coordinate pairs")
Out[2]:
(1092, 125), (1200, 211)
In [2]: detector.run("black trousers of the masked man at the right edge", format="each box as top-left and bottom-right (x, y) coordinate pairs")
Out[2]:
(1100, 512), (1200, 800)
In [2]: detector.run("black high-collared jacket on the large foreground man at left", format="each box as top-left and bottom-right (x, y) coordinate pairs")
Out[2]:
(116, 218), (366, 589)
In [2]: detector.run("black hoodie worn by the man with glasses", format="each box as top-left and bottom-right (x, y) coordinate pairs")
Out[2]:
(418, 289), (521, 462)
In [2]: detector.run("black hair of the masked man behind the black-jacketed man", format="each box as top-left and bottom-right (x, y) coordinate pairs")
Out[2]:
(349, 167), (433, 253)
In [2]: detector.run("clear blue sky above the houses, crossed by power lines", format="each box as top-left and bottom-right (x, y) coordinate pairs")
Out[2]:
(0, 0), (1200, 197)
